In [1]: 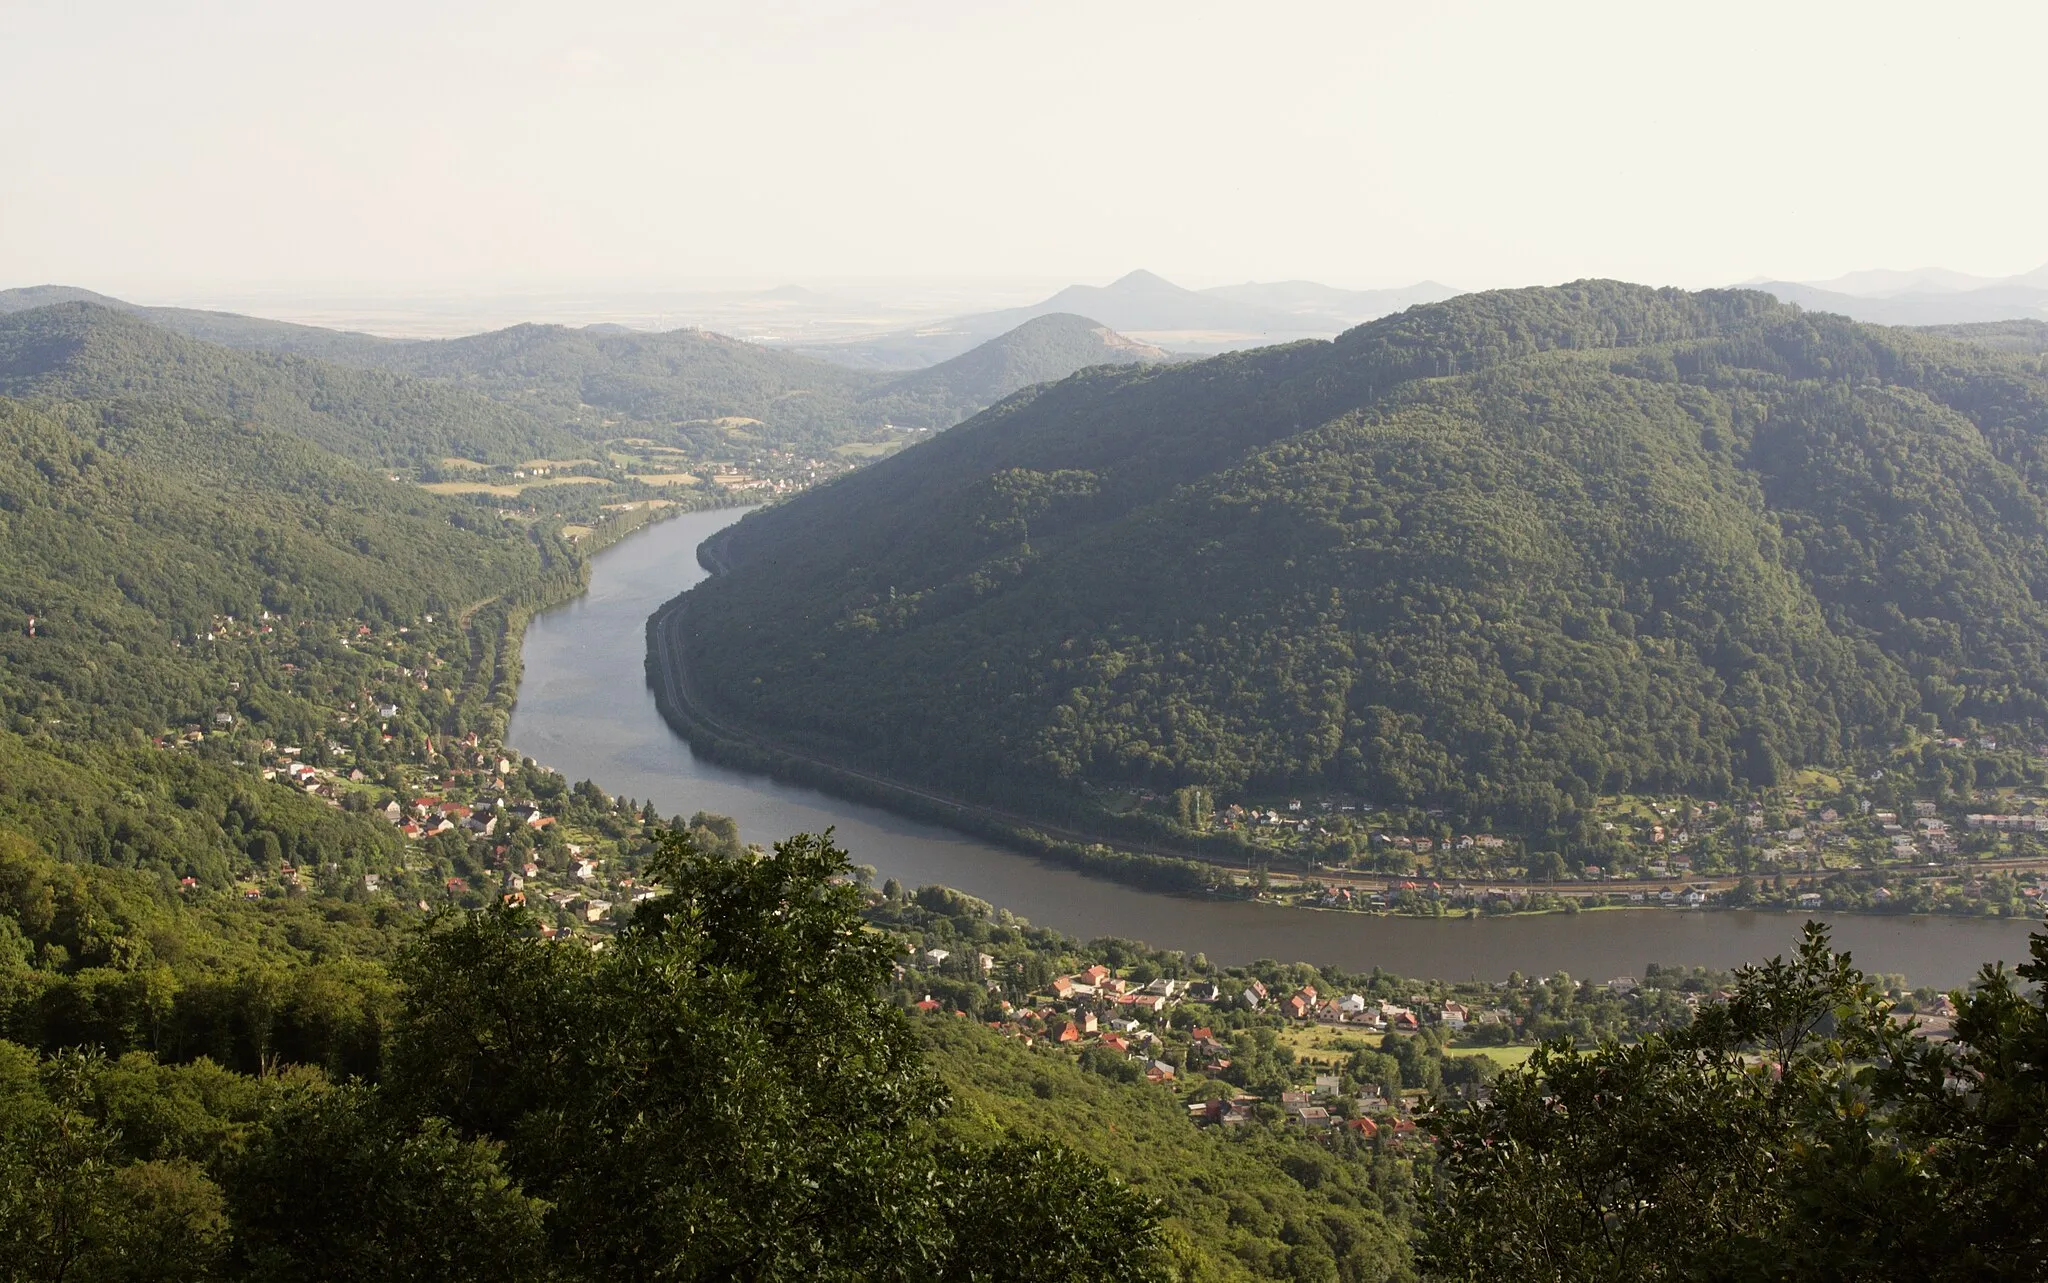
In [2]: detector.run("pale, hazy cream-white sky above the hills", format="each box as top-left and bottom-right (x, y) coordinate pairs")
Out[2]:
(0, 0), (2048, 295)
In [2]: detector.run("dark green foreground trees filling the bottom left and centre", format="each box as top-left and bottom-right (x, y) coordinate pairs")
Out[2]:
(0, 838), (1165, 1281)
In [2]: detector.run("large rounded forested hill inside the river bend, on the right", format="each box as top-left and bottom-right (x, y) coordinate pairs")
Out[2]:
(688, 281), (2048, 826)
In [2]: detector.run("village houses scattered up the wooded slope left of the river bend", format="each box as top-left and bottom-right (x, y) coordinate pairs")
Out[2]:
(142, 611), (688, 922)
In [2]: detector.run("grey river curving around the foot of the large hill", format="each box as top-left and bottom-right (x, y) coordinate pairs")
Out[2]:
(508, 510), (2028, 986)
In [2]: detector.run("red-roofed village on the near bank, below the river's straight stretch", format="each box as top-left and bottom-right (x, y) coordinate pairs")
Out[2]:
(870, 887), (1954, 1146)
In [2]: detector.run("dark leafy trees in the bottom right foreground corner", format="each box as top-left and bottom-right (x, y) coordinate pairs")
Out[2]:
(1419, 924), (2048, 1281)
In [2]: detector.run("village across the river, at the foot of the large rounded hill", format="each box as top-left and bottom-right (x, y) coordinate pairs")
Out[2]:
(1098, 732), (2048, 918)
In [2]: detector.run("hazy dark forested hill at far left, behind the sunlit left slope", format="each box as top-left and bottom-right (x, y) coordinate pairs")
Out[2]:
(0, 301), (575, 465)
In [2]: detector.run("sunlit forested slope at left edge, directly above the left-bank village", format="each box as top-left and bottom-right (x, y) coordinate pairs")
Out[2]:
(0, 400), (573, 742)
